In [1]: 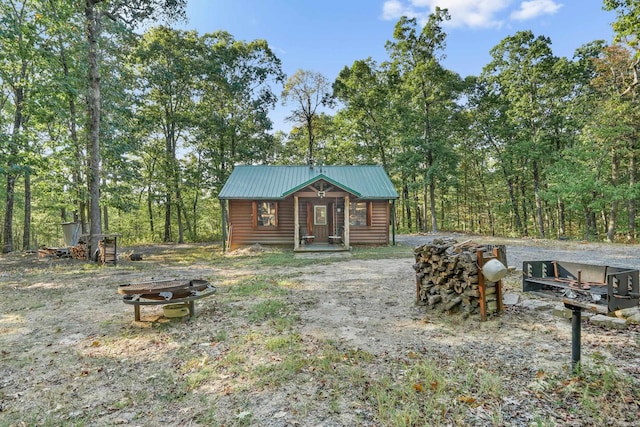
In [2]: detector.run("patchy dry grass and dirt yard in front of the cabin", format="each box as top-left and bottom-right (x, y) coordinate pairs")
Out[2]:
(0, 242), (640, 426)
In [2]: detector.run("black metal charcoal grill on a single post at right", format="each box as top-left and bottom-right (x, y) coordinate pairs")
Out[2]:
(522, 261), (640, 372)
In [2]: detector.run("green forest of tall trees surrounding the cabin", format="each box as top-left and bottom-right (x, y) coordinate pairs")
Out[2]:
(0, 0), (640, 252)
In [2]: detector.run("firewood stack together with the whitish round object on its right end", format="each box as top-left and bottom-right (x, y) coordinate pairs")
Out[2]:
(413, 238), (507, 320)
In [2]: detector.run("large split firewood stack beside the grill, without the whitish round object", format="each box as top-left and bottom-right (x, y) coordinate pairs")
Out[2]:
(413, 239), (498, 316)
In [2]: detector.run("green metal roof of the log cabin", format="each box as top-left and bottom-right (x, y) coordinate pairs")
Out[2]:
(218, 166), (398, 200)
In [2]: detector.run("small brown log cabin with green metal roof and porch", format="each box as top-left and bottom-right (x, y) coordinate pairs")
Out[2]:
(218, 165), (398, 251)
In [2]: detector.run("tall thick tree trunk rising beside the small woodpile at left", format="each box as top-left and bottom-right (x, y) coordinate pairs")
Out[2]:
(85, 0), (102, 258)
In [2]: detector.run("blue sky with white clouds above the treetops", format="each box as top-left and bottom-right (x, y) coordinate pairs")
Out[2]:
(183, 0), (615, 131)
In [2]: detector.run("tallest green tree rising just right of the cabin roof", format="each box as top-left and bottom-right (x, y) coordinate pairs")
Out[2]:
(386, 12), (462, 232)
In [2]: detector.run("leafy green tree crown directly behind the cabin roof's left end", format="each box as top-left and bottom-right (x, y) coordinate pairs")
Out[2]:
(192, 31), (285, 191)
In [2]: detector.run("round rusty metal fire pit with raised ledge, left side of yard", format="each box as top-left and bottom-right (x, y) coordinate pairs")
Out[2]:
(118, 279), (216, 322)
